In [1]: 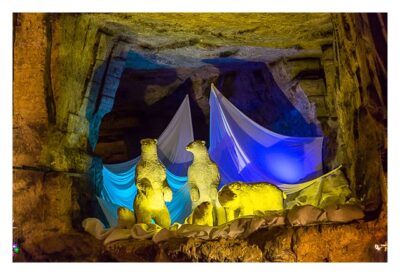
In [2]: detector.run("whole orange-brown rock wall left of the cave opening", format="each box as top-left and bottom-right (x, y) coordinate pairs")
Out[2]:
(13, 14), (123, 254)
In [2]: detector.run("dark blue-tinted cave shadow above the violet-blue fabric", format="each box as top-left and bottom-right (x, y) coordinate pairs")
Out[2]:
(202, 58), (322, 137)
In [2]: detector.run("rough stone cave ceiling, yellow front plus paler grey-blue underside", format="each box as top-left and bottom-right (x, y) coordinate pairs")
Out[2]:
(87, 13), (333, 69)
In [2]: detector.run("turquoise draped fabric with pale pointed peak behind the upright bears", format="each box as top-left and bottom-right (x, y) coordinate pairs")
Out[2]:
(98, 96), (193, 226)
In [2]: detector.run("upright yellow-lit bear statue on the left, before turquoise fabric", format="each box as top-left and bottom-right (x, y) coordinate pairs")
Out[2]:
(134, 138), (172, 227)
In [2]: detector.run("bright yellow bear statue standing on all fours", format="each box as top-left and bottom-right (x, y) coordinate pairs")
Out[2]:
(218, 181), (286, 221)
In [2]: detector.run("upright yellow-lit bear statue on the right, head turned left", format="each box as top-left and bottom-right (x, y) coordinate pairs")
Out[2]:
(186, 140), (220, 210)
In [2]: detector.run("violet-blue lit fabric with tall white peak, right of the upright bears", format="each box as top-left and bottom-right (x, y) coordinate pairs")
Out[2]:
(209, 85), (323, 188)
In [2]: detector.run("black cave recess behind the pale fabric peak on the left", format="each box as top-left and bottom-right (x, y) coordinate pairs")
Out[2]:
(100, 69), (208, 162)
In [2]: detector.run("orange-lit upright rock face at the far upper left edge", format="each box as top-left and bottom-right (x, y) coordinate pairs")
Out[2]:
(13, 14), (48, 166)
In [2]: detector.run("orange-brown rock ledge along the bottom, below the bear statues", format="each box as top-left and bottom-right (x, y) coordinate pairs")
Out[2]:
(14, 213), (387, 262)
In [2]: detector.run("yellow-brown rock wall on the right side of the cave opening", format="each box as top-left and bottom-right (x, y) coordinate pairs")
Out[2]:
(270, 14), (387, 217)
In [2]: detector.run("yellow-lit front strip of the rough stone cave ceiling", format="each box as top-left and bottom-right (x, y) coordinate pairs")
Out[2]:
(89, 13), (333, 50)
